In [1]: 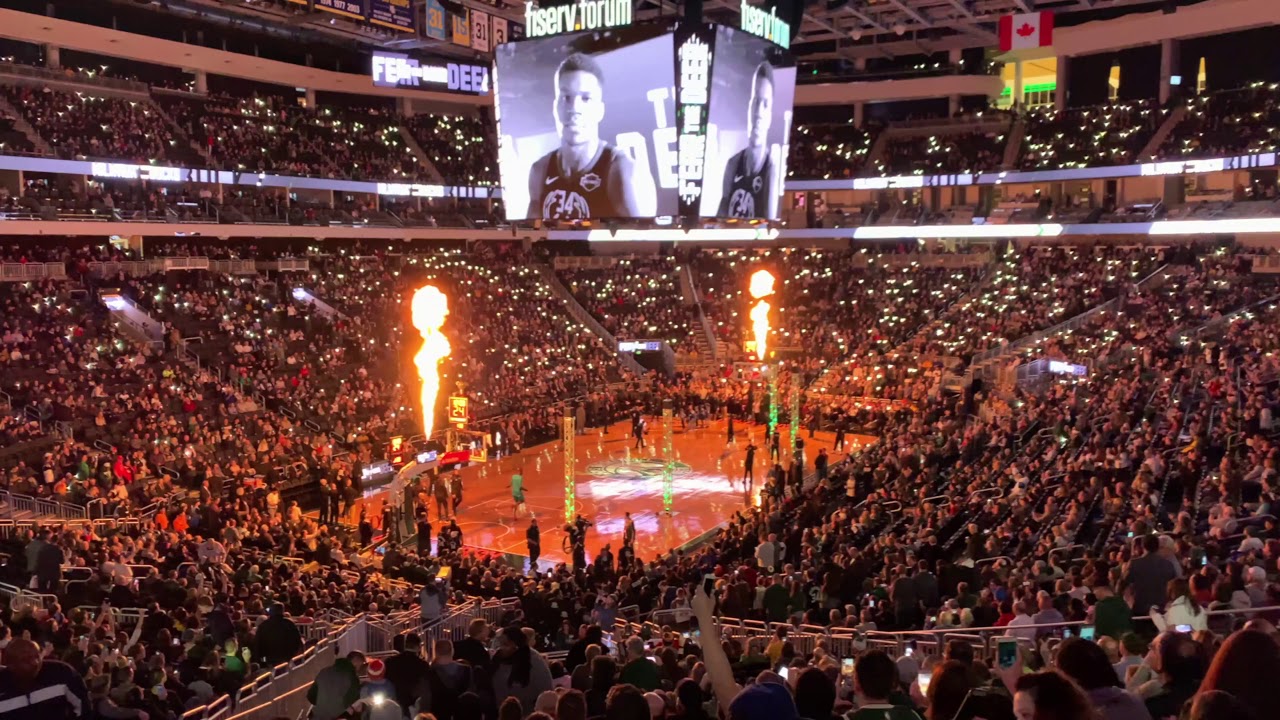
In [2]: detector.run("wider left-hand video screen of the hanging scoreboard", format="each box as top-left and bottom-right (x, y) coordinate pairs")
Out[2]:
(494, 26), (678, 220)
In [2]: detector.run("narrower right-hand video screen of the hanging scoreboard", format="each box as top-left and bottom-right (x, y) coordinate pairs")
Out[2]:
(699, 26), (796, 220)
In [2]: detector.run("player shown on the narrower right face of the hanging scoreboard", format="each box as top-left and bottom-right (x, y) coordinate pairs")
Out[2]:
(718, 63), (778, 218)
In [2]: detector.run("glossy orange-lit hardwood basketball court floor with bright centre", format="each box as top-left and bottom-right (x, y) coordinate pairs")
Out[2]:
(366, 420), (874, 566)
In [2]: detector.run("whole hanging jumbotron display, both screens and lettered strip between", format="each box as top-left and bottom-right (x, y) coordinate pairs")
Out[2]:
(494, 24), (795, 220)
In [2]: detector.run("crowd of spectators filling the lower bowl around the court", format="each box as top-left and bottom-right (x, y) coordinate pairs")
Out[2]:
(0, 234), (1280, 720)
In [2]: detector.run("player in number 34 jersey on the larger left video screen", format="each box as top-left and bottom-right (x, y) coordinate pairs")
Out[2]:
(529, 53), (658, 220)
